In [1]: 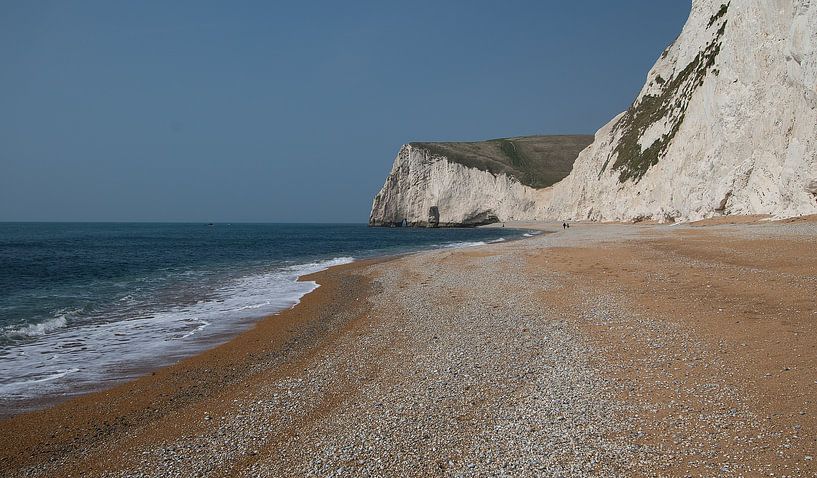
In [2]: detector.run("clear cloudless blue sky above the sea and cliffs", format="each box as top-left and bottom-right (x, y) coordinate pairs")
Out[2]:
(0, 0), (690, 222)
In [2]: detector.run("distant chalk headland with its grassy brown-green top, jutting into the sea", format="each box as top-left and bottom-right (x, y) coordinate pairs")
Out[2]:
(369, 136), (593, 227)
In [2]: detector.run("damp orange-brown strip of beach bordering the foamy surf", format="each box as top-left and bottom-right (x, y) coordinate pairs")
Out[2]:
(0, 256), (388, 469)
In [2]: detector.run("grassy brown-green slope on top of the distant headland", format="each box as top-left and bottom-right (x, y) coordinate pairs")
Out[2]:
(410, 135), (593, 188)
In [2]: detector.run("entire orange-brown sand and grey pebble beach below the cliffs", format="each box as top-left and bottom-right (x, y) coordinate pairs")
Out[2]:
(0, 218), (817, 476)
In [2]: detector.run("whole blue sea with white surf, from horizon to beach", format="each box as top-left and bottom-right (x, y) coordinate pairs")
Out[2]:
(0, 223), (525, 409)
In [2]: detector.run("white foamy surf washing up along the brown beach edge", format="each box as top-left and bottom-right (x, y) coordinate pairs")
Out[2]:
(0, 257), (354, 398)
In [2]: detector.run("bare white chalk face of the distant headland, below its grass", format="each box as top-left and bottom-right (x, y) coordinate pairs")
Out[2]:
(369, 144), (548, 226)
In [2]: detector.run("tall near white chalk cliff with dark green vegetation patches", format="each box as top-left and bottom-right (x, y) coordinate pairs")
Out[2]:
(534, 0), (817, 220)
